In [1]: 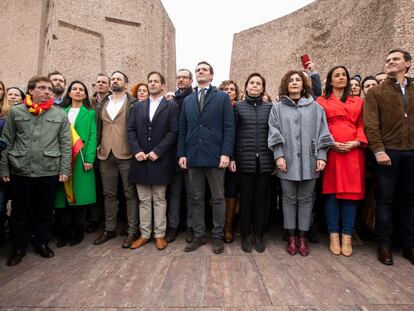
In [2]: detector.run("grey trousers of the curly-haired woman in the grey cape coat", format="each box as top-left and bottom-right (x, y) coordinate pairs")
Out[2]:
(280, 179), (316, 231)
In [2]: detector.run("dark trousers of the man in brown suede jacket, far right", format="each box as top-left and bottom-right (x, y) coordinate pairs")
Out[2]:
(375, 150), (414, 248)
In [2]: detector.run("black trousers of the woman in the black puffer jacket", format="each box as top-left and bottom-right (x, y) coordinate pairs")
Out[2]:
(238, 173), (270, 238)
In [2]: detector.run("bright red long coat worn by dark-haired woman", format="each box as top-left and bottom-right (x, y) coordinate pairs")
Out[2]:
(316, 95), (368, 200)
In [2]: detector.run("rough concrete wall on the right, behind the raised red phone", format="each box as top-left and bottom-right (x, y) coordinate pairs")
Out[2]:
(230, 0), (414, 97)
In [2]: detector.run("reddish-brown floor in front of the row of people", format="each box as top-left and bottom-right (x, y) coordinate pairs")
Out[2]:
(0, 233), (414, 311)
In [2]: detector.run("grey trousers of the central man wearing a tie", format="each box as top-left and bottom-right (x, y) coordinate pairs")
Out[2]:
(188, 167), (226, 237)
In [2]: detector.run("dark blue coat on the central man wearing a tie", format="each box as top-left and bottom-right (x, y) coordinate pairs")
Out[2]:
(177, 86), (234, 168)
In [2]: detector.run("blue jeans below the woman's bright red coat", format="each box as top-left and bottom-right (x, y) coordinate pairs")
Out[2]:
(325, 194), (357, 235)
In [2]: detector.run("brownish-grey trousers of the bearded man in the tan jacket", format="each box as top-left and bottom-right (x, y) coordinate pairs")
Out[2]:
(99, 153), (138, 234)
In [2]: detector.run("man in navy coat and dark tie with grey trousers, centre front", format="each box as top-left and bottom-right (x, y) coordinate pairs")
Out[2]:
(177, 61), (234, 254)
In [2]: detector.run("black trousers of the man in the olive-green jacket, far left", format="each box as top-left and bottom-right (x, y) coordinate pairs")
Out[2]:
(10, 175), (59, 250)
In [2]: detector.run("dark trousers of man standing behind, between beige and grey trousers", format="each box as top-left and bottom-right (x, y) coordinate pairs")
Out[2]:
(168, 172), (193, 229)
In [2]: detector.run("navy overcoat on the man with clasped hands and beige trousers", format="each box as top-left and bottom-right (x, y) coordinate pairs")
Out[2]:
(128, 98), (179, 185)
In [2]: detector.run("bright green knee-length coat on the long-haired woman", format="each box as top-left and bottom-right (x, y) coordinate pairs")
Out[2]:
(55, 105), (96, 208)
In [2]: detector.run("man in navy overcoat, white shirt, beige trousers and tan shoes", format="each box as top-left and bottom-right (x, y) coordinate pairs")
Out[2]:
(128, 71), (179, 250)
